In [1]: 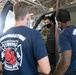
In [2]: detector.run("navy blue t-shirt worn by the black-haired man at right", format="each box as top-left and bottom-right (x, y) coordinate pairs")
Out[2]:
(58, 26), (76, 71)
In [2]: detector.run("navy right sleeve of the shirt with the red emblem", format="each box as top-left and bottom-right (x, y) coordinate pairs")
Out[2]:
(34, 32), (48, 61)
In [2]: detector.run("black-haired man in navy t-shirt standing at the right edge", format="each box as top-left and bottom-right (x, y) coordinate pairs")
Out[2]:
(54, 9), (76, 75)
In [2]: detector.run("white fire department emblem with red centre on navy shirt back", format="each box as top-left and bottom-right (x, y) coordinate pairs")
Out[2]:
(0, 40), (23, 71)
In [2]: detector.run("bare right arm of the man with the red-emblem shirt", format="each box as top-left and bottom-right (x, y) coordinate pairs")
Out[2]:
(38, 56), (51, 75)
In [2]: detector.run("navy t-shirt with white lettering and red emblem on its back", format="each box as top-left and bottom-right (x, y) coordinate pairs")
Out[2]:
(0, 26), (47, 75)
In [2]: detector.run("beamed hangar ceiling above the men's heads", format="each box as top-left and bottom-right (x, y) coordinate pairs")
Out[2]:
(0, 0), (76, 15)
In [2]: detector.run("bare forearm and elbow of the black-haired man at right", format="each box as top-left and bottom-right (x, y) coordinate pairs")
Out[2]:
(54, 50), (72, 75)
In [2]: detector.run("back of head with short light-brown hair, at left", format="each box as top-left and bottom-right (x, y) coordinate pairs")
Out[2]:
(14, 1), (30, 20)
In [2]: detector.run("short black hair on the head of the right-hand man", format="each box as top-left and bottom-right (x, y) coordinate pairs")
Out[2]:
(56, 9), (71, 23)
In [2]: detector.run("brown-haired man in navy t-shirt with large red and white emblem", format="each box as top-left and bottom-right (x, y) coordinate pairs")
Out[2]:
(0, 2), (51, 75)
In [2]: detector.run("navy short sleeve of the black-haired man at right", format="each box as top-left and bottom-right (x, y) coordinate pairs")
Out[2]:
(58, 32), (72, 52)
